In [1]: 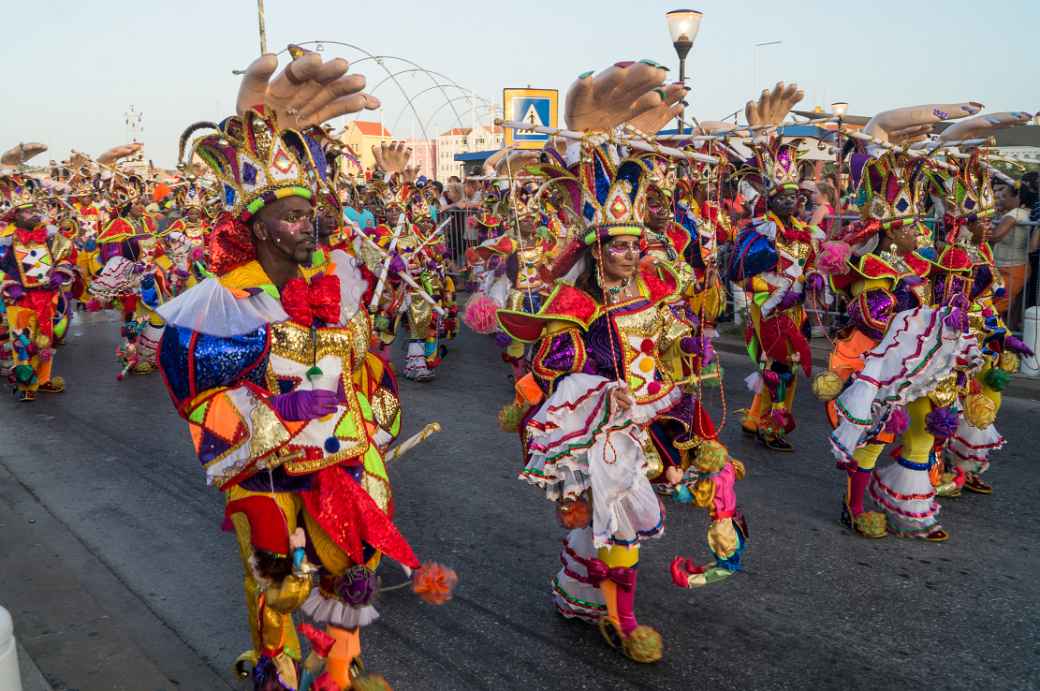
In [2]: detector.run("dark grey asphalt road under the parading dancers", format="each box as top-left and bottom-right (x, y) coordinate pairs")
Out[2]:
(0, 312), (1040, 691)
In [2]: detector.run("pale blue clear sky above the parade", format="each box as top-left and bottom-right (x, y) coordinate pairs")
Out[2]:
(0, 0), (1040, 167)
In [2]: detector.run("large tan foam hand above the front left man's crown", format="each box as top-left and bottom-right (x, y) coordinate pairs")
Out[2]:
(236, 46), (380, 129)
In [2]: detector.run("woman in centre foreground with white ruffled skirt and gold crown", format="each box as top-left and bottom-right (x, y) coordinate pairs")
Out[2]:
(499, 61), (686, 663)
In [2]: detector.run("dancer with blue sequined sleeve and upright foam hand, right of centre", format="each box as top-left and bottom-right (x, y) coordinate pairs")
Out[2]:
(730, 82), (824, 453)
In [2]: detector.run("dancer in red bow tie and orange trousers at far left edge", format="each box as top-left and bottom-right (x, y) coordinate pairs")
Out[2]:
(0, 175), (76, 403)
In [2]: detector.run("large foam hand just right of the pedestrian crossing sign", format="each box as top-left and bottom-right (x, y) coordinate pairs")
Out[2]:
(564, 60), (688, 133)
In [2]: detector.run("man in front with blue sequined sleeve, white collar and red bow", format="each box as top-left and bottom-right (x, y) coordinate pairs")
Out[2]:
(154, 49), (454, 689)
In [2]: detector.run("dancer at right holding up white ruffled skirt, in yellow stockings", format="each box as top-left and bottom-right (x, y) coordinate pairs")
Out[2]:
(822, 103), (1019, 542)
